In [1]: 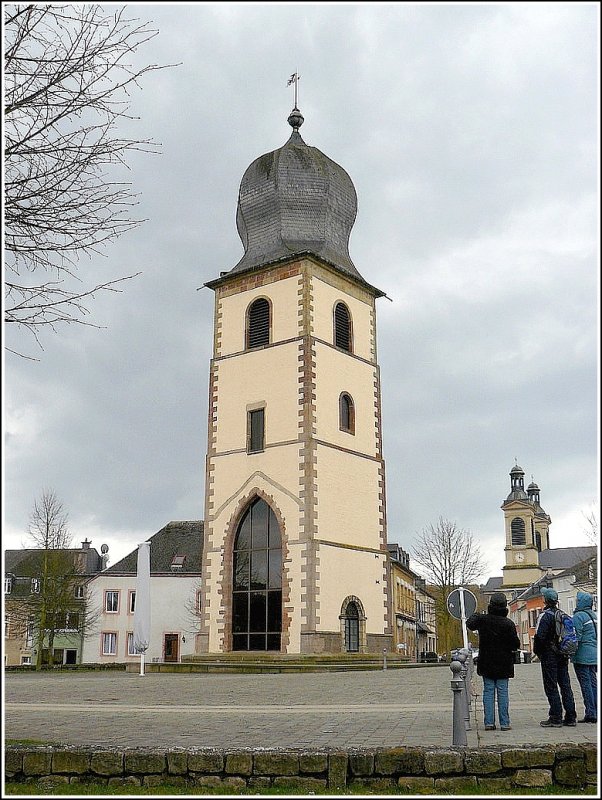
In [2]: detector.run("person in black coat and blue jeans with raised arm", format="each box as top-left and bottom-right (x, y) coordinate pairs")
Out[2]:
(466, 592), (520, 731)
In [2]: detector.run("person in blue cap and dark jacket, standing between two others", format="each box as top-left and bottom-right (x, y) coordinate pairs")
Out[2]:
(533, 587), (577, 728)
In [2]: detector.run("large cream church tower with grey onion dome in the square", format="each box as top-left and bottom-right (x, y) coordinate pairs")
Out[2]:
(199, 107), (391, 653)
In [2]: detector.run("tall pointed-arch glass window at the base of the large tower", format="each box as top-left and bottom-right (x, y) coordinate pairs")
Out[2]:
(232, 498), (282, 651)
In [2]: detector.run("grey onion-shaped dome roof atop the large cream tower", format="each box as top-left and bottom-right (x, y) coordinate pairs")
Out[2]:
(227, 108), (365, 283)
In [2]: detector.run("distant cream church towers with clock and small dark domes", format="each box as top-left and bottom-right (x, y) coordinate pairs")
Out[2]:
(501, 464), (552, 589)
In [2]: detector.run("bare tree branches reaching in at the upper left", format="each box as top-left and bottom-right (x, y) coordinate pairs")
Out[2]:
(4, 3), (176, 352)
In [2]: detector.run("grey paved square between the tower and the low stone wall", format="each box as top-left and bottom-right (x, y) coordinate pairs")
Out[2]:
(4, 664), (597, 748)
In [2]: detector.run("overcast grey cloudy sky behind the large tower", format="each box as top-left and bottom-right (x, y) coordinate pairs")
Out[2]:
(3, 2), (600, 582)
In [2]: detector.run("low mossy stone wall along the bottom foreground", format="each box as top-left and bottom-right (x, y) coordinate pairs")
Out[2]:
(5, 743), (598, 794)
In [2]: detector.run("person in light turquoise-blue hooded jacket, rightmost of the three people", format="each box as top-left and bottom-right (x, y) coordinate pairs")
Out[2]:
(571, 591), (598, 722)
